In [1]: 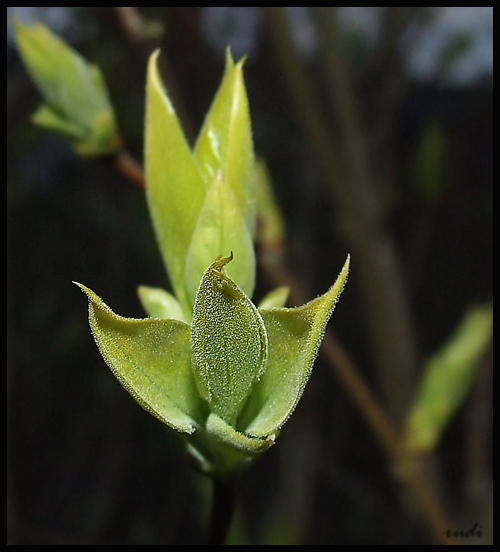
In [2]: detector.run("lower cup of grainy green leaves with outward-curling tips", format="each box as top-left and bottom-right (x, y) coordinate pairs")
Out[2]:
(77, 254), (349, 478)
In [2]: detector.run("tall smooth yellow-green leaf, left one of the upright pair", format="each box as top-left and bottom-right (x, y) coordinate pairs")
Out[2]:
(145, 51), (205, 320)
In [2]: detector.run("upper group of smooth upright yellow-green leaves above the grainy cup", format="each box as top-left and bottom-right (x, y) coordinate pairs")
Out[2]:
(145, 51), (256, 318)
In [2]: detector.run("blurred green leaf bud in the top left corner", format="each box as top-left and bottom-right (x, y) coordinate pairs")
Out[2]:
(13, 18), (120, 156)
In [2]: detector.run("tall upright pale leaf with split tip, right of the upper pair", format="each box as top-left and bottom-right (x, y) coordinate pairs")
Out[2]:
(194, 50), (256, 237)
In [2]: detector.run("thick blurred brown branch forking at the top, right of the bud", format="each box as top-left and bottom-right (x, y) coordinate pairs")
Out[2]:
(265, 7), (416, 430)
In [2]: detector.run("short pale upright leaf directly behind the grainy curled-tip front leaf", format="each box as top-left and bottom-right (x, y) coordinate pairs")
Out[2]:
(186, 175), (255, 303)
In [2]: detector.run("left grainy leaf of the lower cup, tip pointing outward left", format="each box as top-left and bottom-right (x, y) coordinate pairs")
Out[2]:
(77, 284), (200, 433)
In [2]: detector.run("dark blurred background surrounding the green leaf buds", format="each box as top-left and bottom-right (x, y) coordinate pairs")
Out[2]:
(7, 7), (493, 544)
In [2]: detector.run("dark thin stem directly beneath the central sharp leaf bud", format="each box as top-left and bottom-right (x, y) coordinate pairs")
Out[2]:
(207, 479), (236, 546)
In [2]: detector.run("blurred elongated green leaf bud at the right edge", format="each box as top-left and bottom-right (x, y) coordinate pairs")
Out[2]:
(406, 305), (493, 453)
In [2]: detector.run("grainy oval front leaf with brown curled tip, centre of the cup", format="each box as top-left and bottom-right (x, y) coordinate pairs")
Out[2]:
(191, 257), (267, 425)
